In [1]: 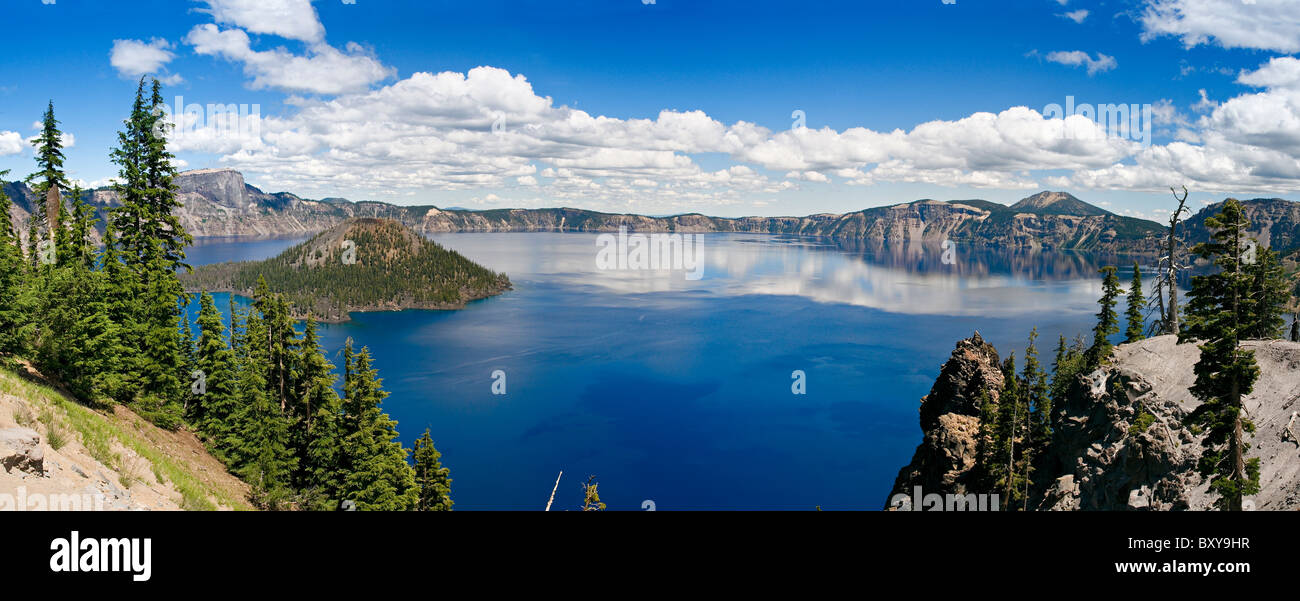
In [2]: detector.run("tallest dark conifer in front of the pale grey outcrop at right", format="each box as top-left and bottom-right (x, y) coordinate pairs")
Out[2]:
(1178, 198), (1260, 511)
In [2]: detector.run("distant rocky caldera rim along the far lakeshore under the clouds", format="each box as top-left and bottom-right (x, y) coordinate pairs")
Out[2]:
(4, 169), (1300, 252)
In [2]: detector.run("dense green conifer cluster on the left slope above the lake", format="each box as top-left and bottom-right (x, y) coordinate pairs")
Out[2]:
(0, 79), (452, 511)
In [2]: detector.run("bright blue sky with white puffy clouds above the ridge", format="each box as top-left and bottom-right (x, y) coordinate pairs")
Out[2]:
(0, 0), (1300, 219)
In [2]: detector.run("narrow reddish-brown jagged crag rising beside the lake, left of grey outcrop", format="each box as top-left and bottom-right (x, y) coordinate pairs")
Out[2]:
(887, 332), (1002, 505)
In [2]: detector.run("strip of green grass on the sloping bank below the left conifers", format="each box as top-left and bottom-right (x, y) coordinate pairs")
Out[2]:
(0, 371), (247, 511)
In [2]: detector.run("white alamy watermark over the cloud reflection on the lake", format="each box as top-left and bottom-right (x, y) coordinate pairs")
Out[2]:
(595, 225), (705, 281)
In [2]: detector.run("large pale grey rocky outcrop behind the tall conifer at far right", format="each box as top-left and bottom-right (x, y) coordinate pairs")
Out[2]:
(1037, 336), (1300, 510)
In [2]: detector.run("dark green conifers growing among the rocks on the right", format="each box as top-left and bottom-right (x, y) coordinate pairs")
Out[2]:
(978, 215), (1297, 510)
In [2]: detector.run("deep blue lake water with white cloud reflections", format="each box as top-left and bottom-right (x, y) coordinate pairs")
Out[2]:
(189, 233), (1145, 510)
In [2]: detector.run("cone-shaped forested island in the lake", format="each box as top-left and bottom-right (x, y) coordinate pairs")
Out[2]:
(181, 217), (511, 323)
